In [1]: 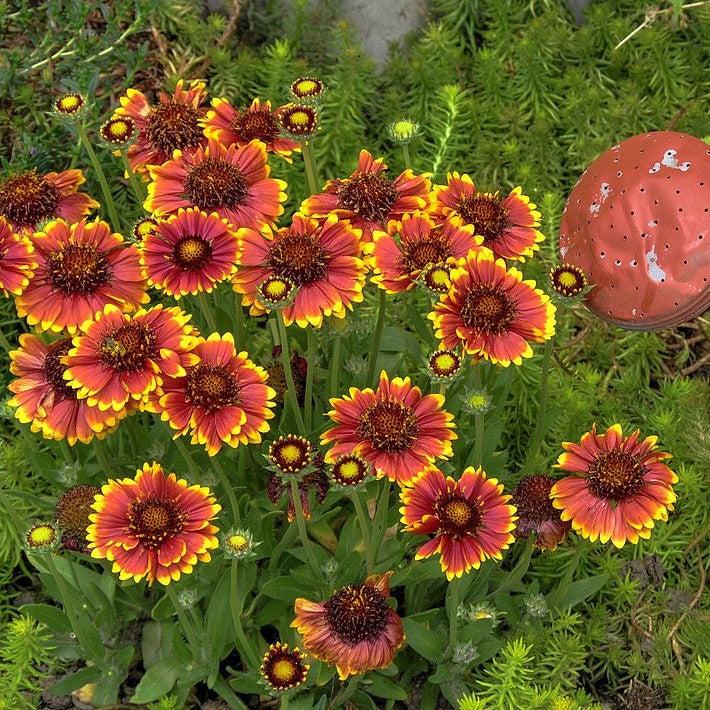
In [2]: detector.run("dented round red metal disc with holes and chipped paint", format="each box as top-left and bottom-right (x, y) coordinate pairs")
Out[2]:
(560, 131), (710, 330)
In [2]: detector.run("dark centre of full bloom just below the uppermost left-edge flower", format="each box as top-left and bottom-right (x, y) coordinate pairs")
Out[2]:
(47, 244), (112, 296)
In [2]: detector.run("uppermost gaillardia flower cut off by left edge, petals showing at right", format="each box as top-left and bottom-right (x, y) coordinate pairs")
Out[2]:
(0, 170), (99, 233)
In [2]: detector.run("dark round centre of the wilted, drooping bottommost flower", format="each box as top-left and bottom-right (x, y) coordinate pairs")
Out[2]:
(323, 584), (389, 644)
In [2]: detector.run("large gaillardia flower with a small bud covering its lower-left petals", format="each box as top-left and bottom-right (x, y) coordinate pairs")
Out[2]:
(233, 213), (365, 328)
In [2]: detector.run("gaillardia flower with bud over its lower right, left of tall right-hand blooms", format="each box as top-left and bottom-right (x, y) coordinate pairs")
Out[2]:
(365, 212), (483, 293)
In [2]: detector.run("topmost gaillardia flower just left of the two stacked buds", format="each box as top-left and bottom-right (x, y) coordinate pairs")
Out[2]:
(205, 99), (301, 162)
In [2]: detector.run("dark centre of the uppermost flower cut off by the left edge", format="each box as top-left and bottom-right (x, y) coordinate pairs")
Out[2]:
(0, 170), (60, 228)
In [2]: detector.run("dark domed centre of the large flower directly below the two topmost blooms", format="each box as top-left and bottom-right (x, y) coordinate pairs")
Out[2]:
(185, 158), (249, 210)
